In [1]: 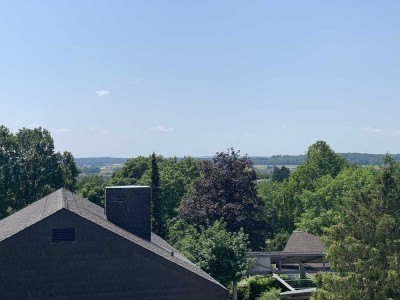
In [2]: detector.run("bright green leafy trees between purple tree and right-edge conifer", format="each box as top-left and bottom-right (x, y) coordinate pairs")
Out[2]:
(258, 141), (350, 250)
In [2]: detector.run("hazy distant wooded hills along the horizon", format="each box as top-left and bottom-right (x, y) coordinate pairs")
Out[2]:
(75, 153), (400, 167)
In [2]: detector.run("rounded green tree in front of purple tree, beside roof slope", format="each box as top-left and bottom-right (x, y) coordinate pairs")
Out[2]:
(169, 219), (250, 286)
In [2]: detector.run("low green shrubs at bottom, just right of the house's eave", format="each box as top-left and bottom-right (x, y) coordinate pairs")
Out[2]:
(238, 276), (280, 300)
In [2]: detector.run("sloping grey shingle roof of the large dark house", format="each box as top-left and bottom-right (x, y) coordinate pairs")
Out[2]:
(0, 188), (225, 288)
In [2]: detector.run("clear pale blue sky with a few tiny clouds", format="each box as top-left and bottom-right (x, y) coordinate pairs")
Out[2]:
(0, 0), (400, 157)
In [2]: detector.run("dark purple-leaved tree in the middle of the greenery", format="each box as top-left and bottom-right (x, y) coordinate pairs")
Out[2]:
(180, 148), (267, 249)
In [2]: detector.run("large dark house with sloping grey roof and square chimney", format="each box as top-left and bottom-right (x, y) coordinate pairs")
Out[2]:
(0, 186), (228, 300)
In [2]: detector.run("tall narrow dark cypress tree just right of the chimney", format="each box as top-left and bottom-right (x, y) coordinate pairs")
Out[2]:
(151, 152), (165, 237)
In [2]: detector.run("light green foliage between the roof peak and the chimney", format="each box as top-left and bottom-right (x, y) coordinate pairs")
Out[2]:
(77, 175), (108, 206)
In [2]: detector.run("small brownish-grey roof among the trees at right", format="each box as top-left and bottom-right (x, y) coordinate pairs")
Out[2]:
(283, 231), (326, 253)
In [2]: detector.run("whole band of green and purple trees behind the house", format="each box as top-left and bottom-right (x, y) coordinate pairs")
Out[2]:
(0, 126), (400, 300)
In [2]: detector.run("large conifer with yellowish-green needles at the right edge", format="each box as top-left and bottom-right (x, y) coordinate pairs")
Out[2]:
(313, 157), (400, 299)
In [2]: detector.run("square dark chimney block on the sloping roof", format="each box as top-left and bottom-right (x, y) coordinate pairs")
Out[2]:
(104, 185), (151, 241)
